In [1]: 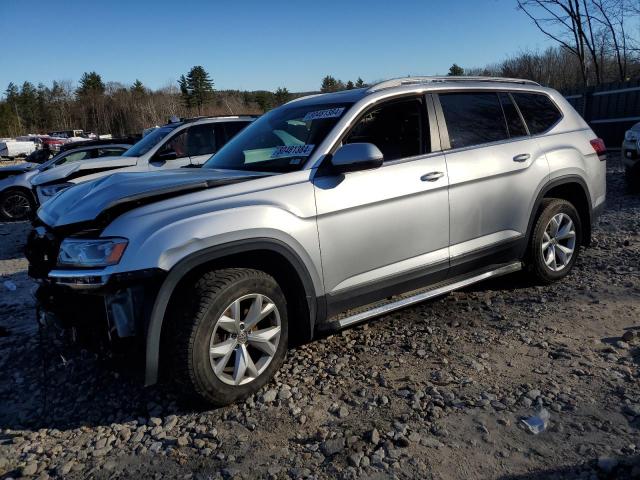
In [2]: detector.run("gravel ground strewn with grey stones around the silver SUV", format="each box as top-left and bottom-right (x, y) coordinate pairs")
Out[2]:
(0, 167), (640, 479)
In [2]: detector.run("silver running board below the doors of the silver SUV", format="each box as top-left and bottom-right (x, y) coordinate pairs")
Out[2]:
(327, 262), (522, 329)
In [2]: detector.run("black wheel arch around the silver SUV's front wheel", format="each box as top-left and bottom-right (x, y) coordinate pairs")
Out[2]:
(144, 238), (318, 385)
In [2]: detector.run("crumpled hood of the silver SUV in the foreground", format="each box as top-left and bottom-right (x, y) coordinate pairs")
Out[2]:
(38, 169), (270, 227)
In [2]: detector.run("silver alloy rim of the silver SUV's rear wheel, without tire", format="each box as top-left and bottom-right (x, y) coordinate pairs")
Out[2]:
(541, 213), (576, 272)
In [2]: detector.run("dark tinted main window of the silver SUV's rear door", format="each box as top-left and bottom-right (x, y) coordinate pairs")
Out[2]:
(439, 92), (509, 148)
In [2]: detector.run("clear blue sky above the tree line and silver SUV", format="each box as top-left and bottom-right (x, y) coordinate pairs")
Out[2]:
(0, 0), (549, 91)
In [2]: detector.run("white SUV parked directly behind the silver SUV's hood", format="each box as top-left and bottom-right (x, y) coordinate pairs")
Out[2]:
(31, 115), (256, 204)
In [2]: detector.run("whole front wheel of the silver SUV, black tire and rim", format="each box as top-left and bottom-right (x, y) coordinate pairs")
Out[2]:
(167, 268), (288, 406)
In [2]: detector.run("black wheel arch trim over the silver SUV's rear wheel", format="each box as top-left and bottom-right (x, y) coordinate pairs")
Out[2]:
(526, 175), (593, 246)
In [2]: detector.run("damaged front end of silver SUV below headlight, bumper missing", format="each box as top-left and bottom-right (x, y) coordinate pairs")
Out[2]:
(25, 225), (165, 376)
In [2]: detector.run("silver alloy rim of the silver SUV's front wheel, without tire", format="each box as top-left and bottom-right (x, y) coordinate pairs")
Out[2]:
(209, 293), (281, 385)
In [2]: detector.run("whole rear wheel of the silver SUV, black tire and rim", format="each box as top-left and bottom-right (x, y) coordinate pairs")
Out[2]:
(529, 198), (582, 283)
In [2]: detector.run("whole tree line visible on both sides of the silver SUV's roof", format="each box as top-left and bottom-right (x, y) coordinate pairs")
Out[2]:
(0, 0), (640, 137)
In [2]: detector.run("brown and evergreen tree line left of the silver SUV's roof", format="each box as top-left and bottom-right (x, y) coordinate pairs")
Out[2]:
(0, 66), (302, 137)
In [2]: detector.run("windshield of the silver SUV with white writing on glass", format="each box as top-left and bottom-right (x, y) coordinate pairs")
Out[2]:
(203, 103), (351, 172)
